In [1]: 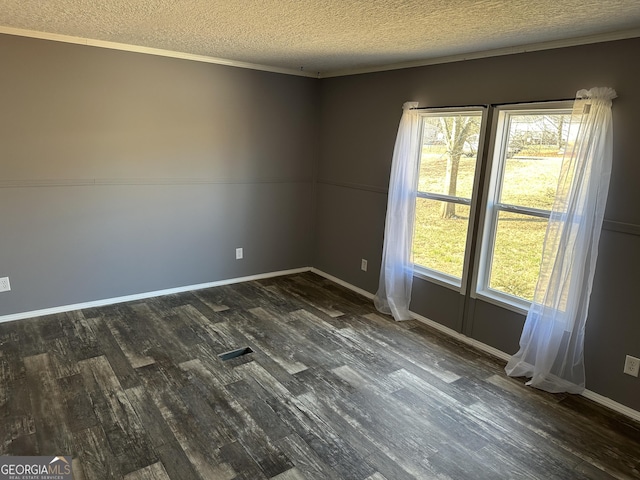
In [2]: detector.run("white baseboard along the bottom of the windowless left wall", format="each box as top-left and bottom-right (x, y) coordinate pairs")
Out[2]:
(0, 267), (311, 323)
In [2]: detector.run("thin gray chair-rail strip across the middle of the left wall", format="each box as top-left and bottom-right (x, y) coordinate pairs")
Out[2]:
(0, 178), (312, 188)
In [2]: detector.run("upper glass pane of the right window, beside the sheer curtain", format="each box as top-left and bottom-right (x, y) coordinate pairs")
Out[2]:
(500, 112), (570, 210)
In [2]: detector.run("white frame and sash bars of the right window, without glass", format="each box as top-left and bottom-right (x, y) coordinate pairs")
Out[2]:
(470, 101), (573, 314)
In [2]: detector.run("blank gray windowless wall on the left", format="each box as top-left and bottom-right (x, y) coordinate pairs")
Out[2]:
(0, 35), (319, 316)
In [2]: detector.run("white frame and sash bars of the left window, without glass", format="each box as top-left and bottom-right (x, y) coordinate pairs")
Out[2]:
(413, 106), (488, 295)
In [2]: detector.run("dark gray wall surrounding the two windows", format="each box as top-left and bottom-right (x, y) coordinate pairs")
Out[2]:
(314, 39), (640, 410)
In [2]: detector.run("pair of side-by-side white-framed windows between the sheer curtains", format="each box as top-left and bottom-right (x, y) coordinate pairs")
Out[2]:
(413, 102), (571, 311)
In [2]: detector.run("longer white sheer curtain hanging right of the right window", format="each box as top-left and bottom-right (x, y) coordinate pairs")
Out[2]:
(505, 88), (616, 393)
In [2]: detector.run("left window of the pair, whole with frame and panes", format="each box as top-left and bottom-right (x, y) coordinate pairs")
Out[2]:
(413, 108), (484, 287)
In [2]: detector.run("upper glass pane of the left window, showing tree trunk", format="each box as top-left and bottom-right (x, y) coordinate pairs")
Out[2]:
(418, 112), (482, 198)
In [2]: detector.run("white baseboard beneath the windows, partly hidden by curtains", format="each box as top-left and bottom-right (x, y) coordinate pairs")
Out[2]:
(311, 268), (640, 422)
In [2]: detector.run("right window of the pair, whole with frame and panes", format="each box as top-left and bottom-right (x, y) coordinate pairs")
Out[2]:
(477, 104), (571, 308)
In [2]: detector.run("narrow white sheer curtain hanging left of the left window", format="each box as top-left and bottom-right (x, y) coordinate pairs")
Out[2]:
(374, 102), (421, 320)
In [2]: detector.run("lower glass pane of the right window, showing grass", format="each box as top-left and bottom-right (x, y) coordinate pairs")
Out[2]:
(489, 212), (548, 301)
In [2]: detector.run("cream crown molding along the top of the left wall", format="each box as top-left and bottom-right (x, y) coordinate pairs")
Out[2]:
(0, 26), (318, 78)
